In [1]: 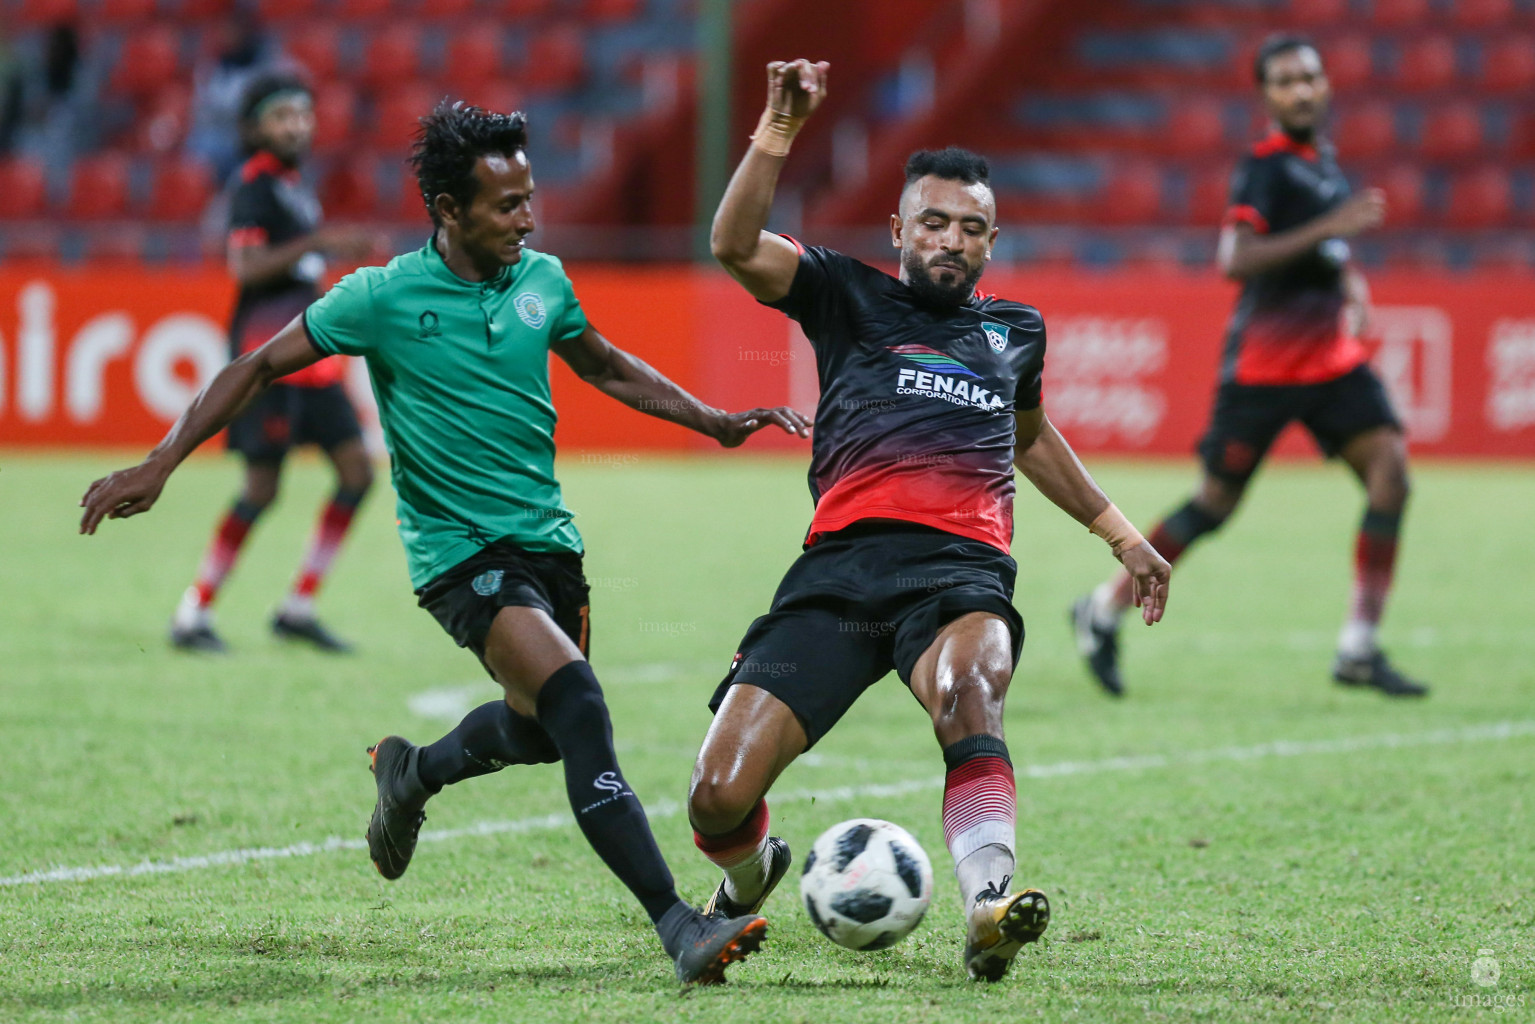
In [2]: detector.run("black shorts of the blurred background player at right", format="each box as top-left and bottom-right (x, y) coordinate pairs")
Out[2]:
(1199, 365), (1401, 484)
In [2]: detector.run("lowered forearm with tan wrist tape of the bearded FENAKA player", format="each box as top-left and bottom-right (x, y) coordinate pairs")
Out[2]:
(1013, 408), (1173, 625)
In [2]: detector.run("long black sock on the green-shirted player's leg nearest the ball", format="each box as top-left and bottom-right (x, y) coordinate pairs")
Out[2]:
(539, 662), (678, 924)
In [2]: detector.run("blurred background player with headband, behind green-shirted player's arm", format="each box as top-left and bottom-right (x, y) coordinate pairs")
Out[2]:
(170, 75), (373, 651)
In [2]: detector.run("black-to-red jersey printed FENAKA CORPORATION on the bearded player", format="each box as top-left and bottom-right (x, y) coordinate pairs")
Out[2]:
(768, 239), (1045, 551)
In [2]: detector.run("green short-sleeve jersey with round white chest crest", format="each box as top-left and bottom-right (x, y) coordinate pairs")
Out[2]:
(304, 241), (586, 588)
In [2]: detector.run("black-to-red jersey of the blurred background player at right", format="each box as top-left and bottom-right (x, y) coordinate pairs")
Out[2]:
(1220, 132), (1366, 384)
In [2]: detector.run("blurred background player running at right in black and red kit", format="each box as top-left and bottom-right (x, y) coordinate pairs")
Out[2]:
(1071, 35), (1428, 697)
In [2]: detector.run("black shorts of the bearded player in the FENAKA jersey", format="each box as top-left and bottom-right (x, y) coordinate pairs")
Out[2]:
(709, 522), (1024, 746)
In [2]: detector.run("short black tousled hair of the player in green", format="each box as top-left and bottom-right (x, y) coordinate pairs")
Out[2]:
(410, 100), (528, 224)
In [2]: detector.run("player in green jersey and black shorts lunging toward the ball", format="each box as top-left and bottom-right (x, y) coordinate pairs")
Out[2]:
(81, 103), (809, 981)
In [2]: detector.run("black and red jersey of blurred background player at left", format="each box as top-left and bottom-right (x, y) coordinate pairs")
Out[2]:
(229, 150), (345, 387)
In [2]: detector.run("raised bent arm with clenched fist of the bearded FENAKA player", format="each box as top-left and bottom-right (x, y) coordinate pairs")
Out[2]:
(709, 60), (830, 302)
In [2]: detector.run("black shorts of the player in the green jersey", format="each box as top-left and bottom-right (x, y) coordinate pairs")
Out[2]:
(416, 540), (591, 677)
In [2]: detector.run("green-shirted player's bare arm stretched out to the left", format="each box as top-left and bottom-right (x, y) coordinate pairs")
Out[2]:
(80, 316), (322, 533)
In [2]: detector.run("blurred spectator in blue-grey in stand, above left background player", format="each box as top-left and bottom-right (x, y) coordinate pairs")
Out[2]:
(186, 11), (293, 181)
